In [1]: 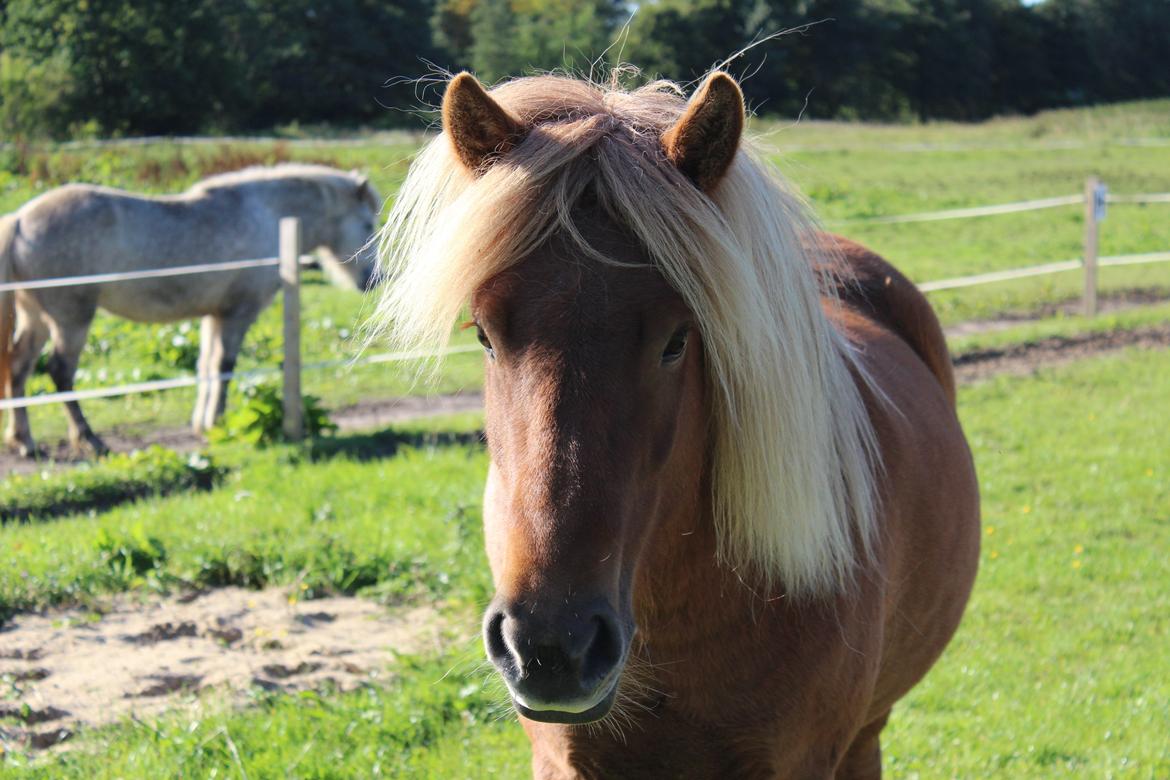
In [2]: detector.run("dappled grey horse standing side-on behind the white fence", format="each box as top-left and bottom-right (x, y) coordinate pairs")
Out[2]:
(0, 165), (381, 456)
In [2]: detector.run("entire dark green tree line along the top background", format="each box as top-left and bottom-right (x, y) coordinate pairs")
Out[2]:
(0, 0), (1170, 137)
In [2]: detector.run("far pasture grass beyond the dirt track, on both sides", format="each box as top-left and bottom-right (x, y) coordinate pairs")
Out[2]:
(0, 101), (1170, 449)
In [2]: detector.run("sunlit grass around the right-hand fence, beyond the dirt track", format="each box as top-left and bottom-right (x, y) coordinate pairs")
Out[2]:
(773, 120), (1170, 323)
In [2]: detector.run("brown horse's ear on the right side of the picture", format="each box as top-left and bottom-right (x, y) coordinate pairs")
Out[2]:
(662, 71), (744, 192)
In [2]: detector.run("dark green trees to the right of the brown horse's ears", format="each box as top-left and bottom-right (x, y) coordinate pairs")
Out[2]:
(632, 0), (1170, 119)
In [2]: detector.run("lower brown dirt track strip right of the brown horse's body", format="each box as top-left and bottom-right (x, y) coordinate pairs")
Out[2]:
(955, 323), (1170, 384)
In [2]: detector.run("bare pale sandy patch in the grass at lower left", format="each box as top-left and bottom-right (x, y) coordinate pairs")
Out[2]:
(0, 588), (441, 750)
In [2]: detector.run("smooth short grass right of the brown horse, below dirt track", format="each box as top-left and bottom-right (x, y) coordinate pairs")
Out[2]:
(886, 352), (1170, 778)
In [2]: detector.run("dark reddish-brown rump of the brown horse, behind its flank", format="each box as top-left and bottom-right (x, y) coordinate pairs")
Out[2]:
(821, 236), (956, 406)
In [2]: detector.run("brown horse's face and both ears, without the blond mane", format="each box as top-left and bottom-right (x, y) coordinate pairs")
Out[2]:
(443, 74), (744, 723)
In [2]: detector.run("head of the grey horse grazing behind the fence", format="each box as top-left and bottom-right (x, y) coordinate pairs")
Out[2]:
(321, 171), (381, 290)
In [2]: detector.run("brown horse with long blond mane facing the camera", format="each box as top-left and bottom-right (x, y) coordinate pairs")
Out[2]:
(379, 73), (979, 778)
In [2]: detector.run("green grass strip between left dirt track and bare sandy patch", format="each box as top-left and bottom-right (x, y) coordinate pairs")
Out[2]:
(0, 415), (488, 616)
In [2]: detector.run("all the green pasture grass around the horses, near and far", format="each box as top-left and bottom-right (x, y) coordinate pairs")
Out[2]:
(0, 102), (1170, 778)
